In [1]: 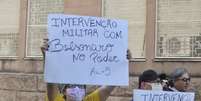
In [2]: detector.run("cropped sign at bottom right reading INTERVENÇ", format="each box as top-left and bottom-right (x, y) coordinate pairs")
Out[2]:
(133, 90), (195, 101)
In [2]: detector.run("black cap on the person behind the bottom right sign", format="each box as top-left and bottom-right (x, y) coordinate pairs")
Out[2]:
(138, 69), (158, 88)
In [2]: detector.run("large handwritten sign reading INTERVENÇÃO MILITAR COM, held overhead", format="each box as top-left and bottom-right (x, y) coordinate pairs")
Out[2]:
(45, 14), (128, 85)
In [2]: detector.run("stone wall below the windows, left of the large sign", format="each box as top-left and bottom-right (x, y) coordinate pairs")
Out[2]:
(0, 59), (46, 101)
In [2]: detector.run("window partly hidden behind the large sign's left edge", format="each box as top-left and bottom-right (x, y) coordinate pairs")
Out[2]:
(26, 0), (64, 57)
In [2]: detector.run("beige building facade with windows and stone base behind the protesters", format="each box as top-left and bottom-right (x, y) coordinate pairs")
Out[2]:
(0, 0), (201, 101)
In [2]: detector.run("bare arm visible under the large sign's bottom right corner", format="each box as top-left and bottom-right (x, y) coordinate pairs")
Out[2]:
(98, 86), (114, 101)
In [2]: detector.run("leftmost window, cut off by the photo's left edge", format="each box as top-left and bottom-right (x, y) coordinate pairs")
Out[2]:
(0, 0), (20, 57)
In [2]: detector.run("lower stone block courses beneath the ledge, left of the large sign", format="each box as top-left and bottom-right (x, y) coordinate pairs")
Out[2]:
(0, 73), (45, 101)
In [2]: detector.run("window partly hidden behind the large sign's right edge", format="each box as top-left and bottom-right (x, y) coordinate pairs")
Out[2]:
(103, 0), (146, 58)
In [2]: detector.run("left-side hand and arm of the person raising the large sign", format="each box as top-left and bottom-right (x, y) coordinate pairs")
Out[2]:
(41, 39), (58, 101)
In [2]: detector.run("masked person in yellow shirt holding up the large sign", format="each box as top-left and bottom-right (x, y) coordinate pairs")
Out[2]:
(41, 39), (131, 101)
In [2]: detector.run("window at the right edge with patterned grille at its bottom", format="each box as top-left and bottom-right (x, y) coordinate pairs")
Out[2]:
(156, 0), (201, 58)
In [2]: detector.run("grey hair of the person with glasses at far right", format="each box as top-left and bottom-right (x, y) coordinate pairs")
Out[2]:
(171, 68), (188, 81)
